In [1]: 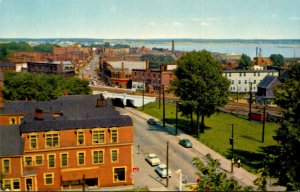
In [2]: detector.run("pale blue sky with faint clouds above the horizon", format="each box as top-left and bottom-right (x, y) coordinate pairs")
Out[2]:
(0, 0), (300, 39)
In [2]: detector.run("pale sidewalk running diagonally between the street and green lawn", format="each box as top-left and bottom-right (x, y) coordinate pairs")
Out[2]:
(126, 108), (285, 191)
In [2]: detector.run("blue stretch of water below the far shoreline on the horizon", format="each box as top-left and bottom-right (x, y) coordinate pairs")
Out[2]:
(145, 42), (300, 58)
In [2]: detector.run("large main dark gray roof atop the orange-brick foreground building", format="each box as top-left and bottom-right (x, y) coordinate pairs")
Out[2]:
(0, 95), (132, 133)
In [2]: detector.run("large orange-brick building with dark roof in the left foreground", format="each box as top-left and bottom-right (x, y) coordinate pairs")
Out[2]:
(0, 95), (133, 191)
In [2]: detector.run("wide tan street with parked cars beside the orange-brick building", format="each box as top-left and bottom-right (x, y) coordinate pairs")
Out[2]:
(117, 109), (200, 191)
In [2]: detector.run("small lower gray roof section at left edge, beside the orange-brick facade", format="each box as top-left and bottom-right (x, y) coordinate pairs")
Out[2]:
(0, 125), (24, 157)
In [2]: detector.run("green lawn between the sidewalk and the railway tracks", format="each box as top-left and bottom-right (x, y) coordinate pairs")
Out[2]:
(138, 102), (279, 171)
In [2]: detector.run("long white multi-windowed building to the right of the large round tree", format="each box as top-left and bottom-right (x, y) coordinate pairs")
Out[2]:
(222, 70), (278, 93)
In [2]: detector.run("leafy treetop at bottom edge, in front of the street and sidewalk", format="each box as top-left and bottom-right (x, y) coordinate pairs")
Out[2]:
(193, 154), (252, 191)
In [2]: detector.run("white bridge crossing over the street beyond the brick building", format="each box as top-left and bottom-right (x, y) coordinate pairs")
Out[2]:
(93, 91), (156, 107)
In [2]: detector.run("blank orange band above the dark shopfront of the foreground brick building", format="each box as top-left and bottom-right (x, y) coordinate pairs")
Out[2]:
(61, 169), (99, 181)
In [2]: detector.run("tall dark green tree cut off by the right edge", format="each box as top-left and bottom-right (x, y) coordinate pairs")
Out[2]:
(272, 64), (300, 191)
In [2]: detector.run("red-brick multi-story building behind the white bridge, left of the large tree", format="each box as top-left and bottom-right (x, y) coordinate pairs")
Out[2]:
(131, 64), (176, 93)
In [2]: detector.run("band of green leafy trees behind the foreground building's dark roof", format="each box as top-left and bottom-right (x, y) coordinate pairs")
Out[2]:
(4, 72), (91, 101)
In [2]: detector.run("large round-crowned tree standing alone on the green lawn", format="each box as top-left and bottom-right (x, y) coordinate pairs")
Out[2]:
(172, 50), (229, 134)
